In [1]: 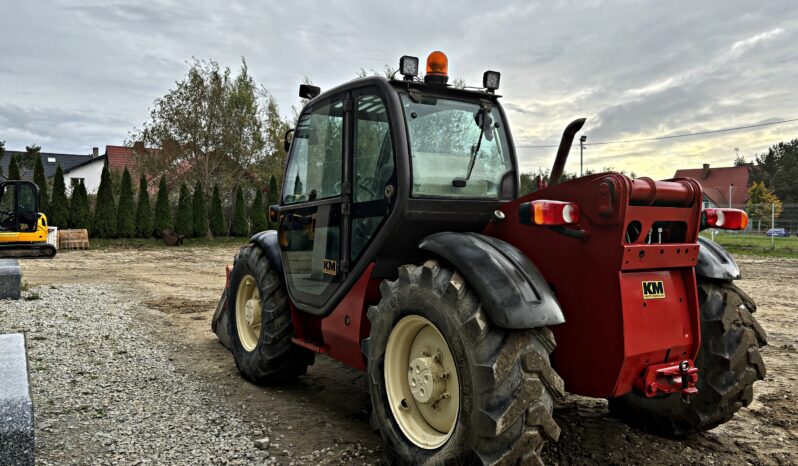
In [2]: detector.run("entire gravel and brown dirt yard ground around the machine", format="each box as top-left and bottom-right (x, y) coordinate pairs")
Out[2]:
(7, 251), (798, 466)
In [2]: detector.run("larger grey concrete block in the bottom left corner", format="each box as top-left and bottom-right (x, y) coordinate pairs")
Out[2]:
(0, 333), (35, 465)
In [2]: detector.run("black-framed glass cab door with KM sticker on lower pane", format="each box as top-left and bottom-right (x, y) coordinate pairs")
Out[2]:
(279, 93), (351, 311)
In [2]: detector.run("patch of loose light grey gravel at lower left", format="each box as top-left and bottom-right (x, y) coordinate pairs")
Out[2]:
(0, 285), (378, 465)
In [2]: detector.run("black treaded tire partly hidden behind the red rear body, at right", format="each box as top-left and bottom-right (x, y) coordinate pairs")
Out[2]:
(609, 278), (767, 437)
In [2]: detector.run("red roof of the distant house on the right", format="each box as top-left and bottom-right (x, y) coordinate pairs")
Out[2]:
(673, 164), (748, 206)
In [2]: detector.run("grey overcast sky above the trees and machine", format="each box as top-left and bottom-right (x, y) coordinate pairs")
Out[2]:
(0, 0), (798, 178)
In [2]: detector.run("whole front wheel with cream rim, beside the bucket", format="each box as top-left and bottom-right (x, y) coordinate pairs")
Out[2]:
(228, 245), (314, 385)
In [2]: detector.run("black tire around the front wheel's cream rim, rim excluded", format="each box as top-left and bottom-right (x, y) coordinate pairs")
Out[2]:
(227, 244), (315, 385)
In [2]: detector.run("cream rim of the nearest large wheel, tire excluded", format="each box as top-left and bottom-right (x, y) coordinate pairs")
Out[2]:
(385, 315), (460, 450)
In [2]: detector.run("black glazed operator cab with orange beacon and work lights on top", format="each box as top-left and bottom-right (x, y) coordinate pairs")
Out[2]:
(275, 52), (518, 315)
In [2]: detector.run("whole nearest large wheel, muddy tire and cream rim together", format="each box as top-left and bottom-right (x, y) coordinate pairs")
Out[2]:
(364, 261), (563, 464)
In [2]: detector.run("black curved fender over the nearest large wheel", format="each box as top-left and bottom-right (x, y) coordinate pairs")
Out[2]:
(419, 232), (565, 329)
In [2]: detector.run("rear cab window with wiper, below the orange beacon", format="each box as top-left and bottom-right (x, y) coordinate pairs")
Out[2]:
(402, 94), (513, 199)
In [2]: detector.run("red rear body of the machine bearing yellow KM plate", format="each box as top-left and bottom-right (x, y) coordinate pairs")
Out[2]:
(484, 173), (701, 397)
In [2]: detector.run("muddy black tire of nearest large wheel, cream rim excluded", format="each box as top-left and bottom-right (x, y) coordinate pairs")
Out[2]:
(363, 261), (564, 464)
